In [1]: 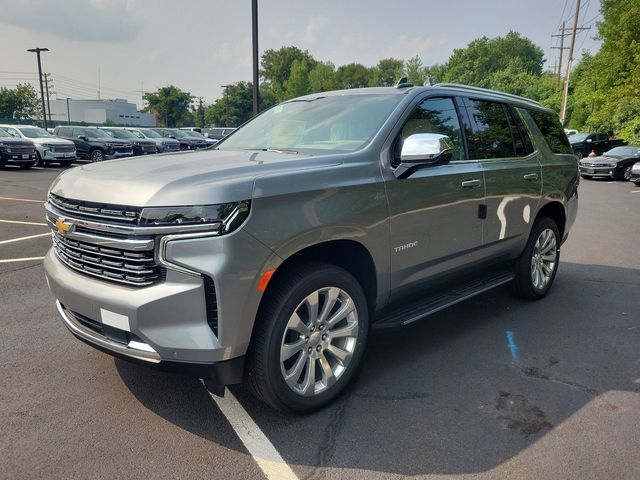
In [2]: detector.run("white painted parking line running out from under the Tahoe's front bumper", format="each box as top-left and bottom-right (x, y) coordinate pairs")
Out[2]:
(204, 389), (298, 480)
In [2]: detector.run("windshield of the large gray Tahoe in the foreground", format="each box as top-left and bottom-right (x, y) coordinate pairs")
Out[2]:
(219, 95), (403, 153)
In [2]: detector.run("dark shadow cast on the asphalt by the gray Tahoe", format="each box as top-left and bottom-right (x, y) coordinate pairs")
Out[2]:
(116, 262), (640, 475)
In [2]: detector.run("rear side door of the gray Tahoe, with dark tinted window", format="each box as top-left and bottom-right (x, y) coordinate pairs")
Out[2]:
(462, 98), (542, 260)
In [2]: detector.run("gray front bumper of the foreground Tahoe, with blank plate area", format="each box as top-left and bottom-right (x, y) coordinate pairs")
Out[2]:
(44, 231), (272, 384)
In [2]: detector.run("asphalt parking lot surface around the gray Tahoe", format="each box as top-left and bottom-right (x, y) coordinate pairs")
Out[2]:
(0, 167), (640, 480)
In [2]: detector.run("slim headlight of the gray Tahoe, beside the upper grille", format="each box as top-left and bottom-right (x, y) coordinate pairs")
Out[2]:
(140, 200), (251, 234)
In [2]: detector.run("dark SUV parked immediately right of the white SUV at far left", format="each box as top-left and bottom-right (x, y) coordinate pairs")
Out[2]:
(53, 125), (133, 162)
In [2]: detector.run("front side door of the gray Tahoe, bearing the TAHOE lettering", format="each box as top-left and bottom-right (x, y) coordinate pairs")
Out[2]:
(387, 97), (484, 300)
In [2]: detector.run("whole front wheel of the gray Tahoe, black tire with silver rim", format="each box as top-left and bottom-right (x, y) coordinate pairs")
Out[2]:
(247, 263), (369, 412)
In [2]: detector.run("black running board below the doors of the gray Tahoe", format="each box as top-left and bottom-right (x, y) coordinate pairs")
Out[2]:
(372, 271), (514, 329)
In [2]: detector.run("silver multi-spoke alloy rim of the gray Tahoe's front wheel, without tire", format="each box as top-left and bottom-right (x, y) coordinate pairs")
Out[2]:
(280, 287), (358, 396)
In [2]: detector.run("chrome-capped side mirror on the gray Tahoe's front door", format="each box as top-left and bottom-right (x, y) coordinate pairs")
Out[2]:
(393, 133), (454, 178)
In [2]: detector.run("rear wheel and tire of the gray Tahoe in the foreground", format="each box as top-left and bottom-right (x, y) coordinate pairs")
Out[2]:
(511, 217), (560, 300)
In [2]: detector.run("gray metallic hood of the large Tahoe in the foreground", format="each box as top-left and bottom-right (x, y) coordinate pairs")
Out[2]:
(51, 150), (340, 207)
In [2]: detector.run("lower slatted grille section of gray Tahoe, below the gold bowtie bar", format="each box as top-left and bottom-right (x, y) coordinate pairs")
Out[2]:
(53, 232), (163, 287)
